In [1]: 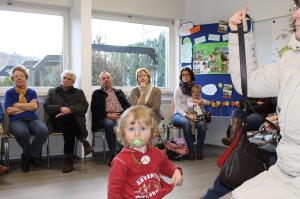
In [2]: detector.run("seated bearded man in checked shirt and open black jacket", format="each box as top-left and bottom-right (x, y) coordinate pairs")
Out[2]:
(91, 72), (131, 166)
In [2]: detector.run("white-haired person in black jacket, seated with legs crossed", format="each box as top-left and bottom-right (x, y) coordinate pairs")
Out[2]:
(44, 70), (94, 173)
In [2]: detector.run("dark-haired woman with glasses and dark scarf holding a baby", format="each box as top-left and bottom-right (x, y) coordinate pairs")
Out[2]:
(172, 68), (206, 160)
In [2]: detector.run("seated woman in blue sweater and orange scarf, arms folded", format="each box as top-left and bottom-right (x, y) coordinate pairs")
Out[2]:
(4, 65), (48, 172)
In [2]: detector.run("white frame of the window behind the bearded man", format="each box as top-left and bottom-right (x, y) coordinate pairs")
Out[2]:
(91, 12), (178, 94)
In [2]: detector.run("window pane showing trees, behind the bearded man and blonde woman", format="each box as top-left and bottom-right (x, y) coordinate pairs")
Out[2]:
(92, 19), (169, 87)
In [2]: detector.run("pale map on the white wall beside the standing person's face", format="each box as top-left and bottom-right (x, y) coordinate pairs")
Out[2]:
(272, 16), (292, 62)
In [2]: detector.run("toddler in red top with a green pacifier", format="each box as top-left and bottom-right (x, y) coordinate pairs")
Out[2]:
(108, 106), (182, 199)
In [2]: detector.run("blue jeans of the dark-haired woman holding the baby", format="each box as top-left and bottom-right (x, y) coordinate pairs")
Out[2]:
(172, 113), (206, 153)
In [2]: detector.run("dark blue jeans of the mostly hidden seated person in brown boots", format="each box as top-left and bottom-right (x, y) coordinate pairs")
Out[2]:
(231, 109), (265, 131)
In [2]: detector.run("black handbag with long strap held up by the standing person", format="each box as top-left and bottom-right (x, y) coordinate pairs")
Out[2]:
(219, 19), (274, 189)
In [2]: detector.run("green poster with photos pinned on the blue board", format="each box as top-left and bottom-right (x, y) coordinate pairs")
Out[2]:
(193, 42), (228, 74)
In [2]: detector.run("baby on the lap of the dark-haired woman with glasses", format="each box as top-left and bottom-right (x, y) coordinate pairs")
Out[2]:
(187, 85), (207, 139)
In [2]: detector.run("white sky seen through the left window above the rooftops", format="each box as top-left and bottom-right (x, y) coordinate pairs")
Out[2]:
(0, 11), (63, 58)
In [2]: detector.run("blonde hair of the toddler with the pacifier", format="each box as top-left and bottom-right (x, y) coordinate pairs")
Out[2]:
(115, 106), (159, 146)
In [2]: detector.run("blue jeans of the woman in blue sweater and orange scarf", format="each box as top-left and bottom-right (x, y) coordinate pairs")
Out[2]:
(9, 118), (49, 157)
